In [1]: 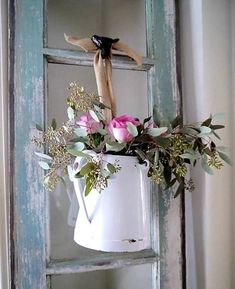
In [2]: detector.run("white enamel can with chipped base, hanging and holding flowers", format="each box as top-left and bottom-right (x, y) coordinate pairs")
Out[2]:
(73, 151), (150, 252)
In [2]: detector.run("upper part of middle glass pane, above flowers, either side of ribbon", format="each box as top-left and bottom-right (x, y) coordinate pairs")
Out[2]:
(48, 64), (148, 123)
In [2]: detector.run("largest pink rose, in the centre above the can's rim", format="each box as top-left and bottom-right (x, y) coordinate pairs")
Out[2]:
(109, 115), (140, 143)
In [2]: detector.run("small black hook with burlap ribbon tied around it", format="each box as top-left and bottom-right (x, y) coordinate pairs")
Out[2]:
(91, 35), (119, 59)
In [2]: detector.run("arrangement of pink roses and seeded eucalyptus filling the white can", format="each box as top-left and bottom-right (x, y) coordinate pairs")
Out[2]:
(33, 82), (230, 197)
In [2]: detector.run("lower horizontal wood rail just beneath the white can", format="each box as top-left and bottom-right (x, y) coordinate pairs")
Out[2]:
(46, 250), (159, 275)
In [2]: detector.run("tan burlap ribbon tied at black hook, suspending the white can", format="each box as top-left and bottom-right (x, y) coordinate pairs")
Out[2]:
(64, 34), (142, 121)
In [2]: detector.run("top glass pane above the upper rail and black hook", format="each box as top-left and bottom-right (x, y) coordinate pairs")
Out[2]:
(48, 0), (146, 55)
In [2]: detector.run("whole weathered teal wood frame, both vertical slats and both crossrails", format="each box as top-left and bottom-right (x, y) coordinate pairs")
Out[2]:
(9, 0), (185, 289)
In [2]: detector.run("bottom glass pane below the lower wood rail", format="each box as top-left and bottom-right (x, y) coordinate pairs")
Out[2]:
(51, 264), (152, 289)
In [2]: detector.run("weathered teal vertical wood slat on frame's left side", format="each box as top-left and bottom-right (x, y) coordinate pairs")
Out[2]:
(11, 0), (47, 289)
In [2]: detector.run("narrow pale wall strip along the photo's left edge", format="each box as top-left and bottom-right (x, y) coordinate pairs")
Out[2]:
(0, 0), (9, 289)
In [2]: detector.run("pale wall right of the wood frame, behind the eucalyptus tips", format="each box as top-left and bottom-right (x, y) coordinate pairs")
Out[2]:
(181, 0), (235, 289)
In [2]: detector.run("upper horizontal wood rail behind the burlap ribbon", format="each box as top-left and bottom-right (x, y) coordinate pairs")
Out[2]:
(43, 48), (154, 71)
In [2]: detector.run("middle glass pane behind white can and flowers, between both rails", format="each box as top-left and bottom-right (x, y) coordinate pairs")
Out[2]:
(48, 64), (148, 259)
